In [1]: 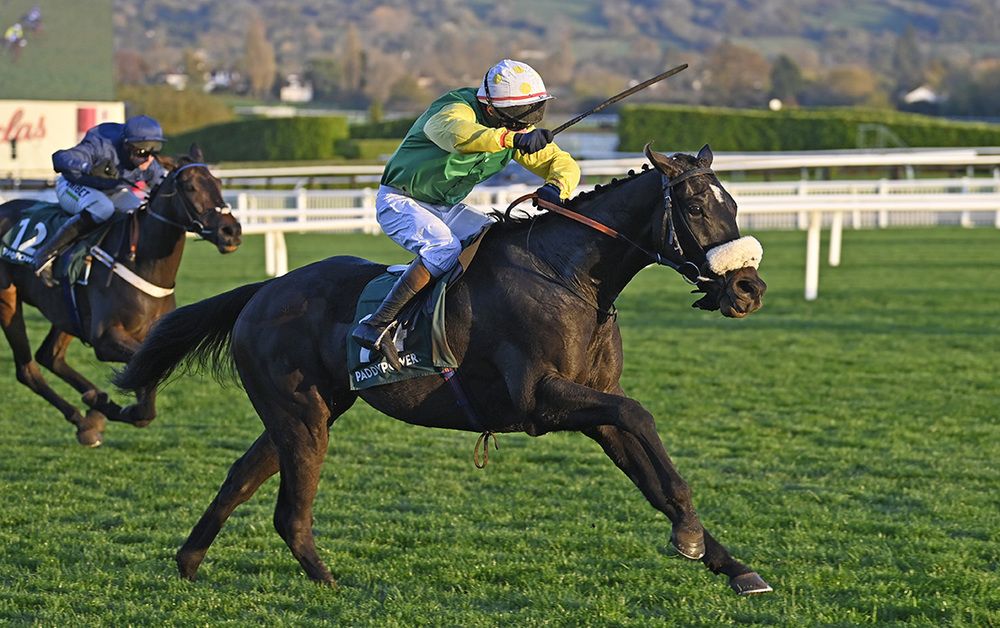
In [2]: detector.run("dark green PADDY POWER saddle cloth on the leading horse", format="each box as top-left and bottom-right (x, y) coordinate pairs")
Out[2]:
(347, 225), (489, 390)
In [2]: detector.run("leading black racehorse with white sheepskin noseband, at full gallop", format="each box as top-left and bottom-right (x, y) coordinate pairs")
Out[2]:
(115, 146), (770, 594)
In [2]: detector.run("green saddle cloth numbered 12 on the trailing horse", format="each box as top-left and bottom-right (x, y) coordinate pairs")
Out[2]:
(0, 201), (114, 283)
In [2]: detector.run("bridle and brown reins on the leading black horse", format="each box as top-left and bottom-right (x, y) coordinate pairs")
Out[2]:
(504, 167), (715, 285)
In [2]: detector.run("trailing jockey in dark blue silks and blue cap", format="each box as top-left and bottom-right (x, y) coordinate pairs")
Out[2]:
(33, 116), (166, 285)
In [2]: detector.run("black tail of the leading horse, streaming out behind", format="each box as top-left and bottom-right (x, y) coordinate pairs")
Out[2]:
(113, 281), (268, 390)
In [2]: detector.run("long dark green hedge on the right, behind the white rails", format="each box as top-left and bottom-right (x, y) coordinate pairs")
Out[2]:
(618, 105), (1000, 151)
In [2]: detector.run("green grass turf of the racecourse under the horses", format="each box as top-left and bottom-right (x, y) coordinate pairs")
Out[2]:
(0, 228), (1000, 626)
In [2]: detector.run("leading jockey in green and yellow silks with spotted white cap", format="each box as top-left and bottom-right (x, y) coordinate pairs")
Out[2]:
(352, 59), (580, 370)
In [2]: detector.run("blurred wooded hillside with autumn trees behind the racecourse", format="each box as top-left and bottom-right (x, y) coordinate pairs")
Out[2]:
(117, 0), (1000, 116)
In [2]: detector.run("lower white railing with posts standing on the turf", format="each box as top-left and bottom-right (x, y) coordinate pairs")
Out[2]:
(226, 173), (1000, 300)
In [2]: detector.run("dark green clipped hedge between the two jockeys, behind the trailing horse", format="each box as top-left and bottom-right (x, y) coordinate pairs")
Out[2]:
(174, 116), (348, 162)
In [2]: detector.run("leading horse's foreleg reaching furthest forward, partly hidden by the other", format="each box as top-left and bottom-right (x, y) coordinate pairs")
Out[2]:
(586, 426), (771, 595)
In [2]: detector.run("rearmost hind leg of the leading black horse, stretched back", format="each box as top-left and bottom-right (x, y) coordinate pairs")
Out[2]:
(176, 432), (278, 580)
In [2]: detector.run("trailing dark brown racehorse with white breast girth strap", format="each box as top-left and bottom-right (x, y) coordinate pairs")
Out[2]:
(0, 146), (241, 447)
